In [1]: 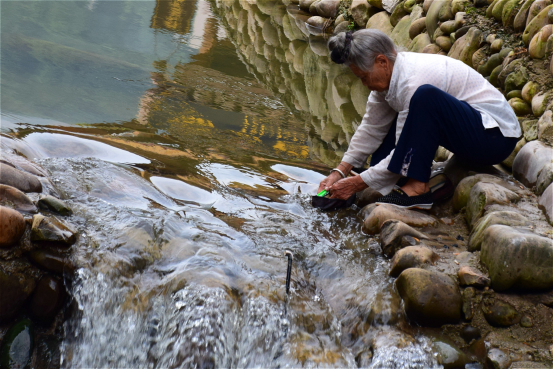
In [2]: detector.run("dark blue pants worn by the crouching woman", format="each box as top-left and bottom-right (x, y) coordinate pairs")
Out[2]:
(370, 85), (518, 182)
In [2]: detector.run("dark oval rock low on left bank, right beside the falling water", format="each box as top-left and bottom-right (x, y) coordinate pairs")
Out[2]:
(31, 276), (65, 322)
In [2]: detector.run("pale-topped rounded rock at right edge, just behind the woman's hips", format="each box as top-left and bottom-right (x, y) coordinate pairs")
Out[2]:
(512, 141), (553, 187)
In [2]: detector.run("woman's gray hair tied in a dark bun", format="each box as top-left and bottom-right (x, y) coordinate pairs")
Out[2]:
(327, 29), (399, 72)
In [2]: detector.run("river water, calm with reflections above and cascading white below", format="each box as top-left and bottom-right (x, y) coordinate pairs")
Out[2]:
(1, 0), (436, 368)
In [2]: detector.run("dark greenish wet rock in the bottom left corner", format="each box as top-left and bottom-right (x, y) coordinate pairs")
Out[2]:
(0, 319), (34, 369)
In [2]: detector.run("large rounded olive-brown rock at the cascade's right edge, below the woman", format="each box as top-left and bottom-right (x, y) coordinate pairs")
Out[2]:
(395, 268), (462, 326)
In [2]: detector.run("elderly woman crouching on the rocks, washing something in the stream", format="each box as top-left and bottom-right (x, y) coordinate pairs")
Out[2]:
(319, 29), (521, 209)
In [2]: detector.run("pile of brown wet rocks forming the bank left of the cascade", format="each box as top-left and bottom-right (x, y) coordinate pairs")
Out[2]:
(0, 151), (77, 369)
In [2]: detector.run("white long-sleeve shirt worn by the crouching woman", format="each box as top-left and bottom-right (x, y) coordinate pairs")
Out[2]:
(342, 52), (521, 194)
